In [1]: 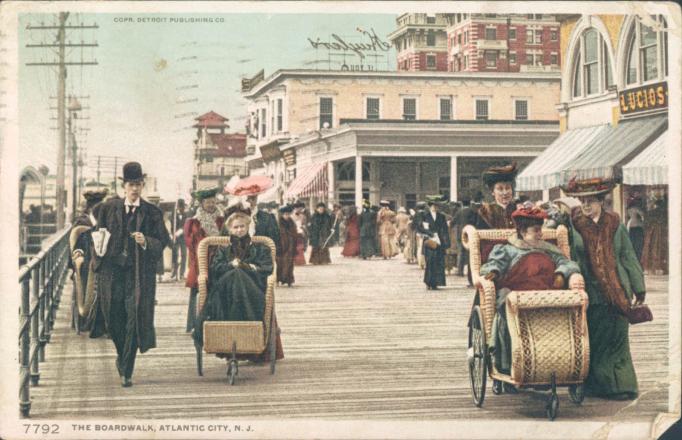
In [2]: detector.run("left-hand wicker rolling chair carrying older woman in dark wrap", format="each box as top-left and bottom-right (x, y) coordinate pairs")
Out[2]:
(197, 236), (277, 383)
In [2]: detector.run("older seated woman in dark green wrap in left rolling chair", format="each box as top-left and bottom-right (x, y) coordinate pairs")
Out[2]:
(194, 212), (273, 346)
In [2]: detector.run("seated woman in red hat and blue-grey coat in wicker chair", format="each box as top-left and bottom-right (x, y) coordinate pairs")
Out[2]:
(481, 203), (584, 384)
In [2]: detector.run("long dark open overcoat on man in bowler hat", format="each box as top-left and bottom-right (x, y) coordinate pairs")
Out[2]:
(95, 199), (170, 353)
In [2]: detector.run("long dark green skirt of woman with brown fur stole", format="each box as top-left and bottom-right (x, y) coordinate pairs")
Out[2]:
(585, 304), (638, 399)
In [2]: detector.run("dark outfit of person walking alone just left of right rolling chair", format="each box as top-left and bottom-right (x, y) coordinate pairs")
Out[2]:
(417, 211), (450, 287)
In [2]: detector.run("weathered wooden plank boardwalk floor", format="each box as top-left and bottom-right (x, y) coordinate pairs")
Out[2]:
(31, 248), (668, 421)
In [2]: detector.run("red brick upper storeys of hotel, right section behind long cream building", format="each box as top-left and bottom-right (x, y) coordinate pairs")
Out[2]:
(444, 14), (561, 72)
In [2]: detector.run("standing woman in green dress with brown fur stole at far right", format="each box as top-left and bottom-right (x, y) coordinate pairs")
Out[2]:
(562, 179), (646, 400)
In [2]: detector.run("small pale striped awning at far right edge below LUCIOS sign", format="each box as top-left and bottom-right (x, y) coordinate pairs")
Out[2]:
(623, 130), (670, 185)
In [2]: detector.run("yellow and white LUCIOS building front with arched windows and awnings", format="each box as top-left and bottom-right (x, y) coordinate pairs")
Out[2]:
(517, 15), (673, 215)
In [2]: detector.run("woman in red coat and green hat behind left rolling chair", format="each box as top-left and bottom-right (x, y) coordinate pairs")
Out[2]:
(183, 188), (225, 333)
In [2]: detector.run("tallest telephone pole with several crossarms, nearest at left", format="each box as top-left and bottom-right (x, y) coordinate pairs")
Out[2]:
(26, 12), (99, 230)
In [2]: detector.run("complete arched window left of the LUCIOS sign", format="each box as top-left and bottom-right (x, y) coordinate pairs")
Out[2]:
(572, 28), (613, 98)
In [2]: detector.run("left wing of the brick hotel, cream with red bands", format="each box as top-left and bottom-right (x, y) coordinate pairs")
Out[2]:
(388, 14), (448, 72)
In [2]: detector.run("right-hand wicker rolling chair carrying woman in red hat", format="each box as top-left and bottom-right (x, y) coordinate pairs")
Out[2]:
(462, 225), (590, 419)
